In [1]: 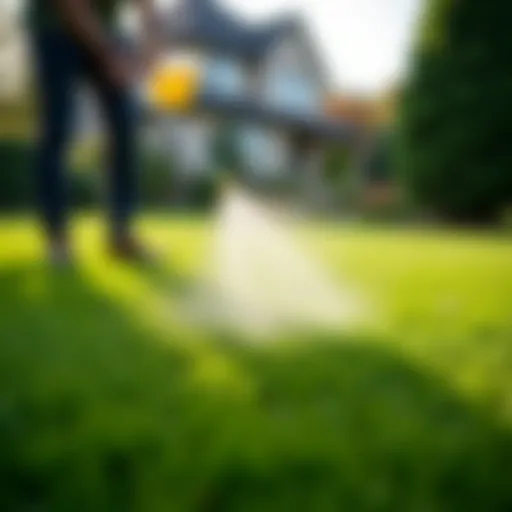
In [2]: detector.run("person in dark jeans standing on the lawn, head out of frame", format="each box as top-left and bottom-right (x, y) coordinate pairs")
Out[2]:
(28, 0), (158, 264)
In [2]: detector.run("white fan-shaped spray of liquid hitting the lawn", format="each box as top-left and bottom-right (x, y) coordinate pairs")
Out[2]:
(182, 184), (363, 334)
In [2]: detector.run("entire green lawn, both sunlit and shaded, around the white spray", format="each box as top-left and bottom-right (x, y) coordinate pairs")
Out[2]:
(0, 217), (512, 512)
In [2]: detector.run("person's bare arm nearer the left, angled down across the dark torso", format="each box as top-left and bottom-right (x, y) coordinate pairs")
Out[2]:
(52, 0), (129, 83)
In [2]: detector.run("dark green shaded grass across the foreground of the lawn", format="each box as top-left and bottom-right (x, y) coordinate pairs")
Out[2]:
(0, 266), (512, 512)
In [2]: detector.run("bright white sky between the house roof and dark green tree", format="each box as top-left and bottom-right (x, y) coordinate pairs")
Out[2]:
(4, 0), (424, 94)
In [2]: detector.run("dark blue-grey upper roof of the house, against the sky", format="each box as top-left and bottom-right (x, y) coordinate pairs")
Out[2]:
(164, 0), (298, 59)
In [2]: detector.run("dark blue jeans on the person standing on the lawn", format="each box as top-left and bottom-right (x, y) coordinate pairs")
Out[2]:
(32, 29), (137, 236)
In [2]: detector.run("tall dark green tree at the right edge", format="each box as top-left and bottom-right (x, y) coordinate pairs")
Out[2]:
(400, 0), (512, 222)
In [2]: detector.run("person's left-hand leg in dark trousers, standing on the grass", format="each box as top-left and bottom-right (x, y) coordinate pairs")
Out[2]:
(32, 31), (78, 259)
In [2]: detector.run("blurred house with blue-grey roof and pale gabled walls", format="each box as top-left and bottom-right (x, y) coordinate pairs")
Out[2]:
(142, 0), (355, 186)
